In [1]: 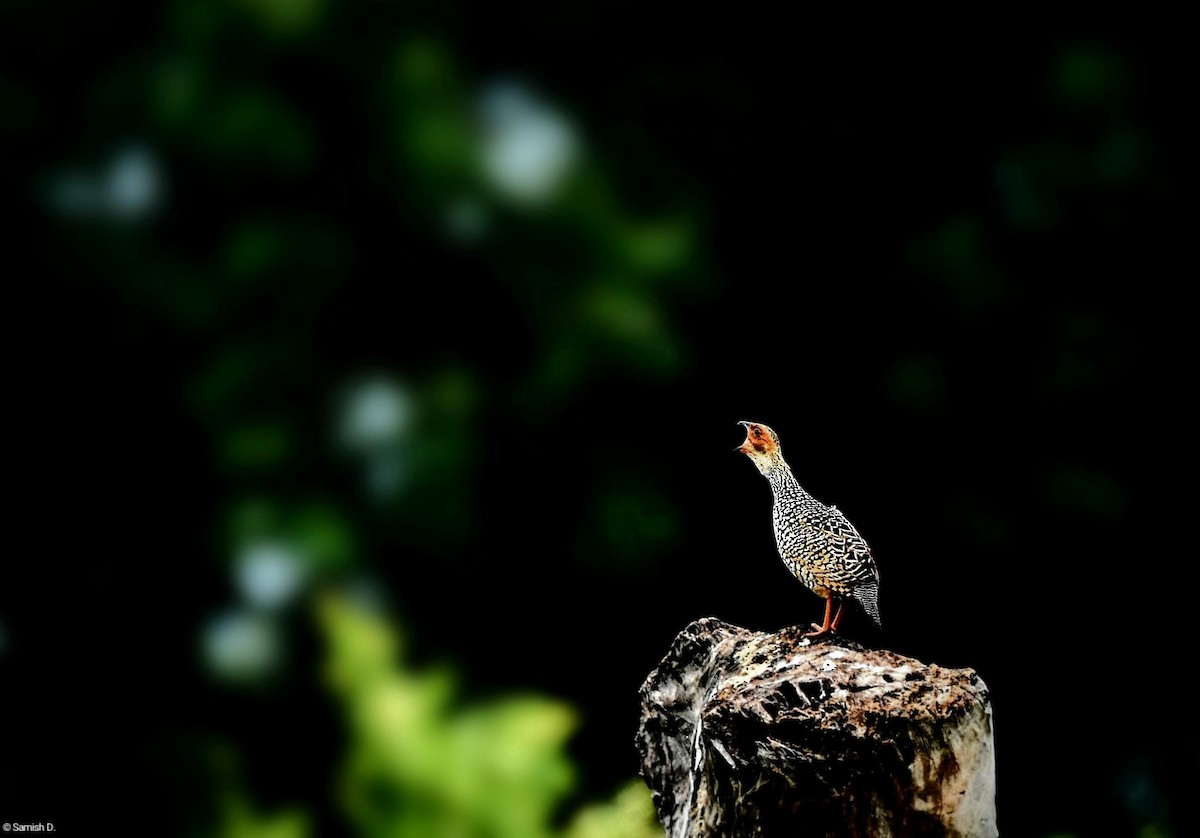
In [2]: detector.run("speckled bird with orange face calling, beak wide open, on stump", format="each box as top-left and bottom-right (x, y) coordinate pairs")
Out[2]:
(736, 421), (882, 638)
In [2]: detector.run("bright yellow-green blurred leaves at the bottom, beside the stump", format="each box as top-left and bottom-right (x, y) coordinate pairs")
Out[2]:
(319, 595), (659, 838)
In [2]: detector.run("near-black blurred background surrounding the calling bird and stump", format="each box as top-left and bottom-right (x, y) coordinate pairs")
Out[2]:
(0, 2), (1200, 836)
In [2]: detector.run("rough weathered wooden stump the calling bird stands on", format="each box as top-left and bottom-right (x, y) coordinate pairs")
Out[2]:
(637, 618), (998, 838)
